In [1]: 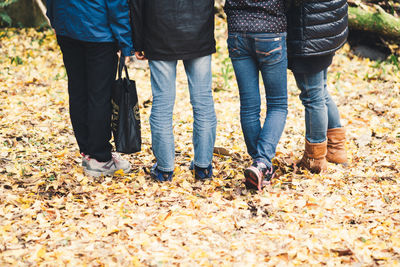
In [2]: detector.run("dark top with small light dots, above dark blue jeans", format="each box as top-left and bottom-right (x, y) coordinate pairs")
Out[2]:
(224, 0), (287, 33)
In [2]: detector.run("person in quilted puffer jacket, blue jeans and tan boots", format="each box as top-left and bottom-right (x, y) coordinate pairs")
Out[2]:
(288, 0), (348, 173)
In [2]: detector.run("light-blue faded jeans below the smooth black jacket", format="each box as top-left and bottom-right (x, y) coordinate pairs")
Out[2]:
(149, 55), (217, 172)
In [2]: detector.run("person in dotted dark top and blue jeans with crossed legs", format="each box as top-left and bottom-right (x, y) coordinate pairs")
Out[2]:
(224, 0), (288, 193)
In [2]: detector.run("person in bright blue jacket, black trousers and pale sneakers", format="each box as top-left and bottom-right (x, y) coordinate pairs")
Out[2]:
(47, 0), (134, 177)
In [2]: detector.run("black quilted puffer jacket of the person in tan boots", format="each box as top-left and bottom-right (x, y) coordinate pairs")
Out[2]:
(287, 0), (348, 57)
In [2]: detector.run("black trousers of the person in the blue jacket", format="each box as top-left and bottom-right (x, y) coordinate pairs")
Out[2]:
(57, 36), (118, 162)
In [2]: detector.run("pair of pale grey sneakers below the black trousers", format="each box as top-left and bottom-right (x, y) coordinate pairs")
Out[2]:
(84, 153), (131, 177)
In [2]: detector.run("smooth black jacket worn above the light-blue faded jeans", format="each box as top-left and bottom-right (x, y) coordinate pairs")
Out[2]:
(130, 0), (215, 60)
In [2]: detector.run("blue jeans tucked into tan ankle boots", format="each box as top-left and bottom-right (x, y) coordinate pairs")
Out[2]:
(293, 69), (342, 143)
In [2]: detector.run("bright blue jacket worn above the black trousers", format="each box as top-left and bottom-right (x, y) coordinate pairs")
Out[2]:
(47, 0), (134, 56)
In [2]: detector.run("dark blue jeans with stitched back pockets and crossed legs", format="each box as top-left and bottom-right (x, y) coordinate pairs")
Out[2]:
(228, 33), (288, 167)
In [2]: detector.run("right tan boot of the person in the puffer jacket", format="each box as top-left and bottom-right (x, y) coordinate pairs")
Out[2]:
(326, 127), (348, 166)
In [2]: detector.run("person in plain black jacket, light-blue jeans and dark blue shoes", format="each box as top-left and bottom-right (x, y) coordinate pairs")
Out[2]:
(131, 0), (217, 181)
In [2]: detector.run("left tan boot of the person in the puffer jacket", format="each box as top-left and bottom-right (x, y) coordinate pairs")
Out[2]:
(299, 139), (327, 173)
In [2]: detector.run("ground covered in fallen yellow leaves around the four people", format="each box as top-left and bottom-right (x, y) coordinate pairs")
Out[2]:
(0, 20), (400, 266)
